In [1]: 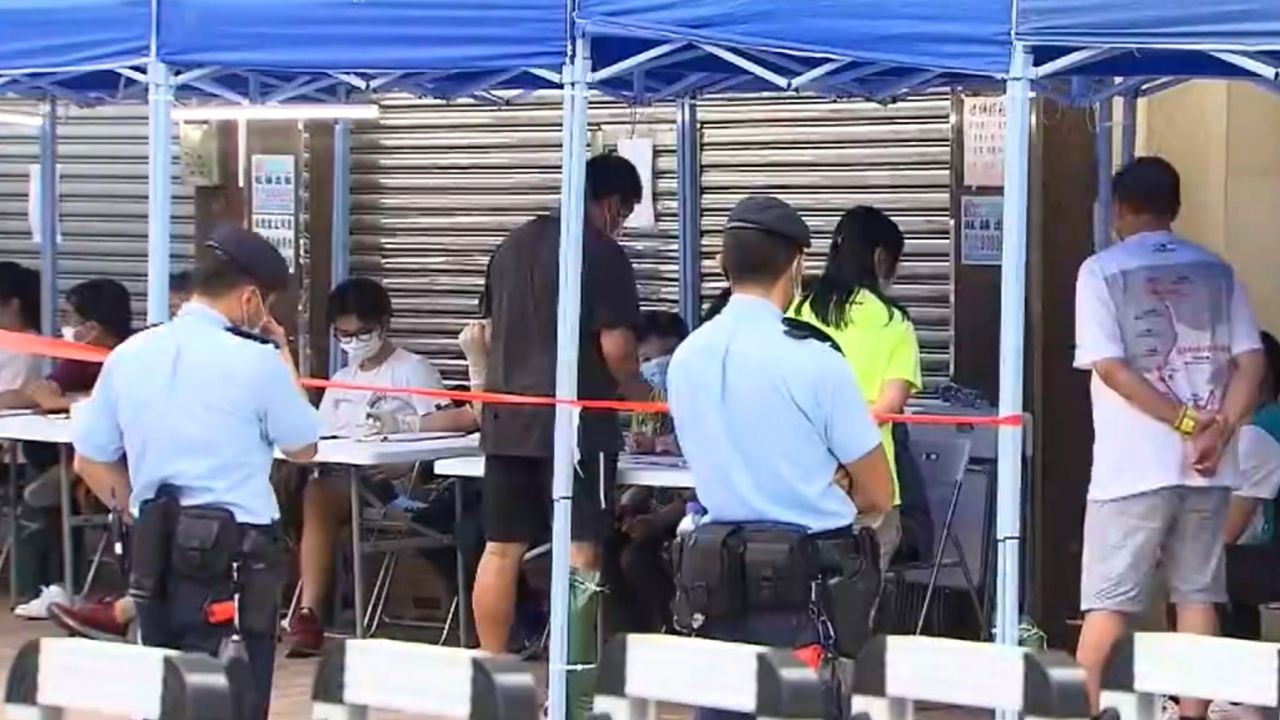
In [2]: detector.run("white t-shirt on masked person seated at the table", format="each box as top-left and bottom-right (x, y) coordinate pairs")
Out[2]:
(320, 347), (449, 437)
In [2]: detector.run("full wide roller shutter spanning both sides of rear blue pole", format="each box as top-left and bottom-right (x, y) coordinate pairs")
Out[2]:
(351, 96), (951, 383)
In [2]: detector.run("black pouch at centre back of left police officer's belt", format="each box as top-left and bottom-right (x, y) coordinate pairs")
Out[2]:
(172, 505), (241, 584)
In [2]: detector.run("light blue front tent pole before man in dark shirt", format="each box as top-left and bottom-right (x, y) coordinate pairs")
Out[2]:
(548, 37), (589, 720)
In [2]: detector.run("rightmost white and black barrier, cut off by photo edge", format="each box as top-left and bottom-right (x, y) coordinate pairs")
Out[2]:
(1101, 633), (1280, 720)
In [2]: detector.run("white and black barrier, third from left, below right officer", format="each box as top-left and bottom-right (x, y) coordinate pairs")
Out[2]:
(591, 635), (823, 720)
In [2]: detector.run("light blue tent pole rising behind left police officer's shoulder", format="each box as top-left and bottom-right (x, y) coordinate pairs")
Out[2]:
(147, 60), (173, 325)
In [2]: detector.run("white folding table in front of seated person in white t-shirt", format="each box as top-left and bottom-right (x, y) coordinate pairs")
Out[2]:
(276, 433), (480, 638)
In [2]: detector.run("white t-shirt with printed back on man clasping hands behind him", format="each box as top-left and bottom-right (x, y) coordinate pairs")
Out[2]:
(1075, 232), (1261, 500)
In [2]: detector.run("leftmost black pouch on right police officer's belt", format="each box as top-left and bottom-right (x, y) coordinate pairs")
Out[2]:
(671, 523), (746, 633)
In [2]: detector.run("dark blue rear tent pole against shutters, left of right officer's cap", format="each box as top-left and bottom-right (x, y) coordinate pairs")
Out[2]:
(676, 97), (703, 328)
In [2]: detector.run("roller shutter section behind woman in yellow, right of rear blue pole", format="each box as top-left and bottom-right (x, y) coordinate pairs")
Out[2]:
(698, 95), (951, 387)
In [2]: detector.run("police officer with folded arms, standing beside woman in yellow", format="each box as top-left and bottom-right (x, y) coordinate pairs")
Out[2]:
(667, 196), (893, 717)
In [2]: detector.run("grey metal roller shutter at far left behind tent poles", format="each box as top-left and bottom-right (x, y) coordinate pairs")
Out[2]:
(0, 106), (195, 319)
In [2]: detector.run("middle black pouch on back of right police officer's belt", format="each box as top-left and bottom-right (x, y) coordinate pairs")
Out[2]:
(741, 523), (818, 612)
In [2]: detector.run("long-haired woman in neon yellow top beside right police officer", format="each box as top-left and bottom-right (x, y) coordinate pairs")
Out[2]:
(791, 205), (922, 566)
